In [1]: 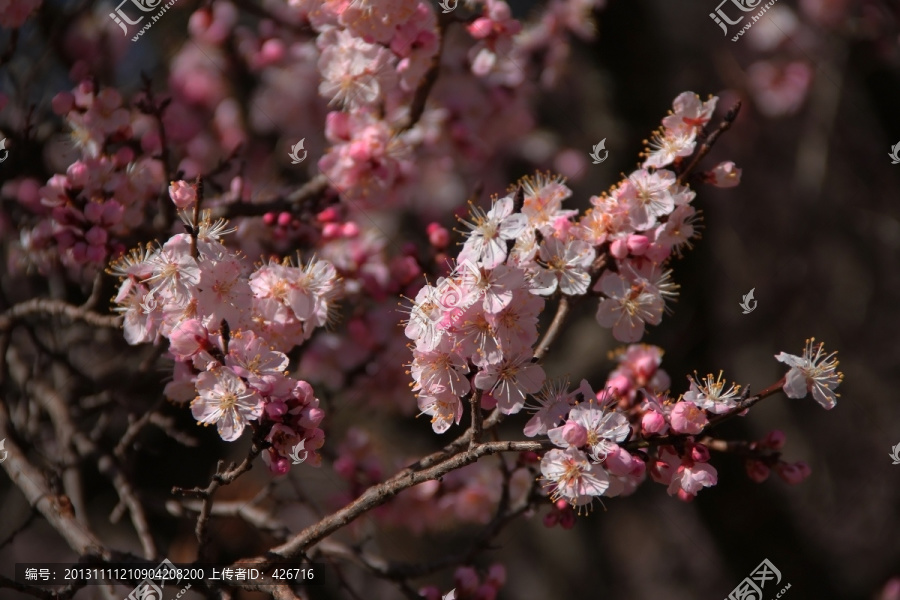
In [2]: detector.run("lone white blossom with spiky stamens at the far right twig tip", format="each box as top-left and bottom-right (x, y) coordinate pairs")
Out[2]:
(775, 338), (844, 409)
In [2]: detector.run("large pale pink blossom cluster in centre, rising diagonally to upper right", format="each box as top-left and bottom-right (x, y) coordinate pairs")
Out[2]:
(406, 92), (740, 433)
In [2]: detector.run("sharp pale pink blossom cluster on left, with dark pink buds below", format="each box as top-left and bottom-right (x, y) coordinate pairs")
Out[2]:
(110, 181), (340, 474)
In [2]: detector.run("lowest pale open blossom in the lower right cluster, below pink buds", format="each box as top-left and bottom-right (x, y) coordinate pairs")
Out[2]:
(541, 446), (609, 506)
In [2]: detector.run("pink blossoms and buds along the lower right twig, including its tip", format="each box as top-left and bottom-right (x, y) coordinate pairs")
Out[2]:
(525, 332), (843, 506)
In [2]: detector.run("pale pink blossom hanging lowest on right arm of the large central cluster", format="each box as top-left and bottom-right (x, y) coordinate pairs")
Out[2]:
(594, 272), (665, 342)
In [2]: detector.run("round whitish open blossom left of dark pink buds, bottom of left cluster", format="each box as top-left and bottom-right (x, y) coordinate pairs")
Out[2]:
(191, 366), (263, 442)
